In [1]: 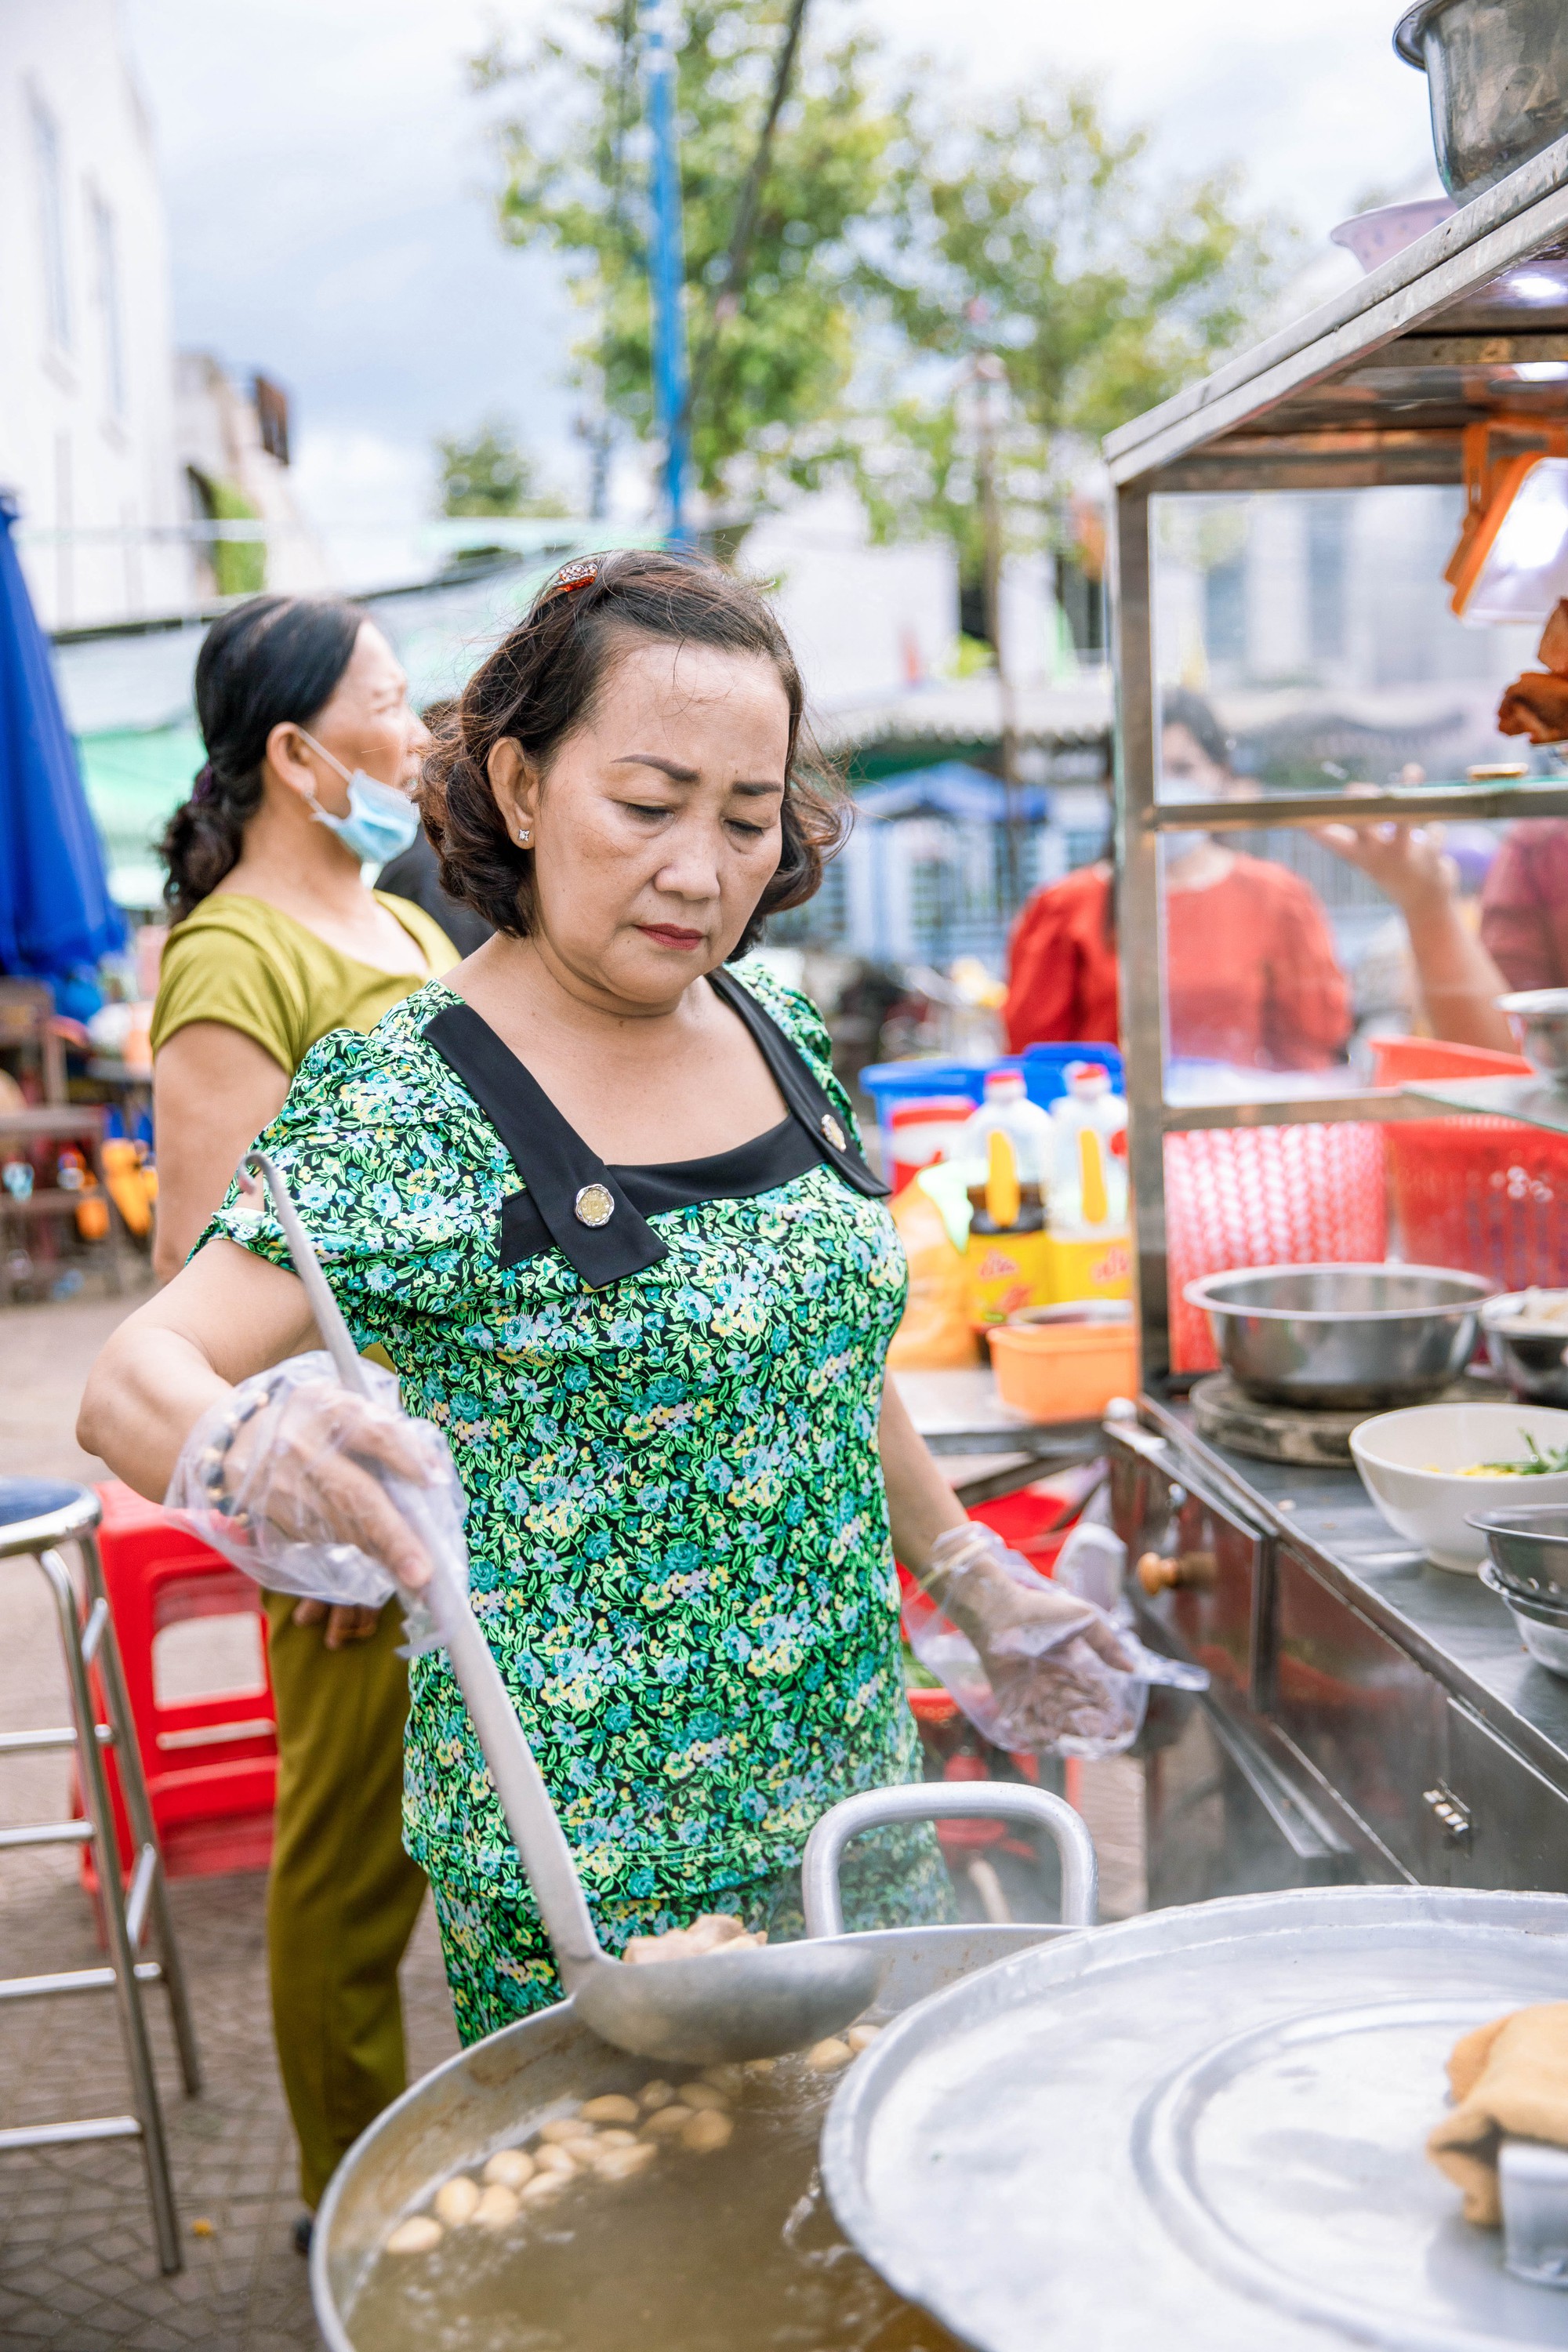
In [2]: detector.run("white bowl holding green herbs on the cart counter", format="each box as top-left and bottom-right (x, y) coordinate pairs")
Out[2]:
(1349, 1404), (1568, 1576)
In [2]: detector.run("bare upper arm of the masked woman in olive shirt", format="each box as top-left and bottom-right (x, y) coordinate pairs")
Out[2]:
(153, 1021), (289, 1282)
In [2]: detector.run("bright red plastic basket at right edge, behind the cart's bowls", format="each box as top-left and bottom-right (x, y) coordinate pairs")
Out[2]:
(1373, 1037), (1568, 1291)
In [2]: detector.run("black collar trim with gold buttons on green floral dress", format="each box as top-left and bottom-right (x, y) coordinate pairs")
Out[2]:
(426, 971), (888, 1289)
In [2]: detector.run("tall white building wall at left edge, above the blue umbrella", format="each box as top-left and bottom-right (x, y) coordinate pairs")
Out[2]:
(0, 0), (191, 628)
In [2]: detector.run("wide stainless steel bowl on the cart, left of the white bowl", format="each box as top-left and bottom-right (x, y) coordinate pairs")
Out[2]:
(1185, 1265), (1490, 1411)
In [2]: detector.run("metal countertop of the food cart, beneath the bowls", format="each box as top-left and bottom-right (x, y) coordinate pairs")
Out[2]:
(1145, 1399), (1568, 1790)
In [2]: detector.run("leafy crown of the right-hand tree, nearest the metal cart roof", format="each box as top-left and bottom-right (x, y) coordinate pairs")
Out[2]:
(839, 80), (1288, 579)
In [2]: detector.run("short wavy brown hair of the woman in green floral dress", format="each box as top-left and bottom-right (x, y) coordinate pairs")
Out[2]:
(419, 548), (848, 960)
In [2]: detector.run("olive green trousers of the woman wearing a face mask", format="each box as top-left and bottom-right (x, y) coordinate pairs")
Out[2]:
(263, 1592), (426, 2209)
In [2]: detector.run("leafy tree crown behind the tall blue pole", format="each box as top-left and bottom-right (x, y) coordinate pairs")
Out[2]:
(477, 0), (898, 496)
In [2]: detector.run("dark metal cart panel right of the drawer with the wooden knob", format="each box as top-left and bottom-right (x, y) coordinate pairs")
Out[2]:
(1272, 1548), (1448, 1884)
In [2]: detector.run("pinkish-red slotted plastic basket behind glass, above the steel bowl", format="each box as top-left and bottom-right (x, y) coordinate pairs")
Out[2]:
(1166, 1120), (1392, 1371)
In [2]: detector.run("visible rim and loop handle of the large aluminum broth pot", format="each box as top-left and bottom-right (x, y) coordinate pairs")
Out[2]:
(310, 1780), (1095, 2352)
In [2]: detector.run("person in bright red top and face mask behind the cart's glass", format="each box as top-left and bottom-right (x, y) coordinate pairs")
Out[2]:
(1006, 691), (1352, 1070)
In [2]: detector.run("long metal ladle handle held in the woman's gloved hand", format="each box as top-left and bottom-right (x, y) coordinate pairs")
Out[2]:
(245, 1152), (607, 1992)
